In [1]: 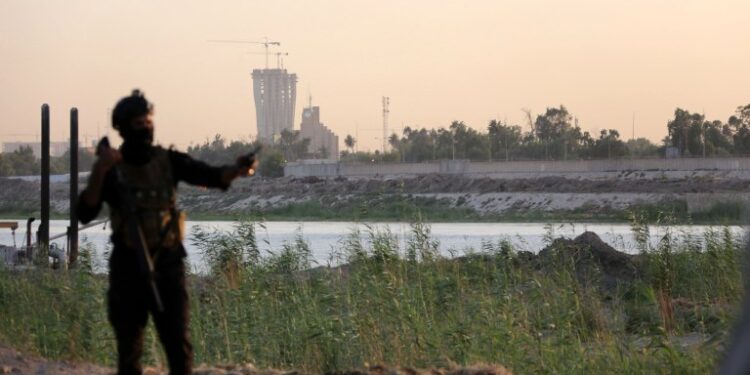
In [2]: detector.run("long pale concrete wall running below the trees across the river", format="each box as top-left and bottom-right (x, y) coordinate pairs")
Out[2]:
(284, 158), (750, 177)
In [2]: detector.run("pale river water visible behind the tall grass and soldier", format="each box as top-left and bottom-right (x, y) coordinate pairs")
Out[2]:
(0, 219), (742, 272)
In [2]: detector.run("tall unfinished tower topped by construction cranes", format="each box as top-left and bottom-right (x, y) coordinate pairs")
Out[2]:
(253, 69), (297, 143)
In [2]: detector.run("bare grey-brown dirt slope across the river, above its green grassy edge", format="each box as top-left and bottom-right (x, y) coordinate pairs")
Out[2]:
(0, 172), (750, 214)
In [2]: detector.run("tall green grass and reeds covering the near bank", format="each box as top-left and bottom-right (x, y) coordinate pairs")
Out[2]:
(0, 220), (744, 374)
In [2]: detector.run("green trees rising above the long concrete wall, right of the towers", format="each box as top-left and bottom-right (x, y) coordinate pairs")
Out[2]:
(342, 104), (750, 162)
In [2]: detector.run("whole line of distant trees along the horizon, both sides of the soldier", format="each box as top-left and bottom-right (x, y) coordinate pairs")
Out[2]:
(0, 104), (750, 177)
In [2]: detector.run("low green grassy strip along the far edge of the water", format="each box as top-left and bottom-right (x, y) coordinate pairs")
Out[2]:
(0, 200), (747, 225)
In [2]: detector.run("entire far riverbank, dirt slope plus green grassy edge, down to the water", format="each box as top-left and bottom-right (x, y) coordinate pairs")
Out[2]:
(0, 172), (750, 225)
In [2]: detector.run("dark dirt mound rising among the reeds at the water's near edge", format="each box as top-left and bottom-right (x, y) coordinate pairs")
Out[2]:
(538, 232), (638, 290)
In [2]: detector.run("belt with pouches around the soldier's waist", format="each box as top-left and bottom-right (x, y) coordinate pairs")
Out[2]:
(112, 208), (185, 254)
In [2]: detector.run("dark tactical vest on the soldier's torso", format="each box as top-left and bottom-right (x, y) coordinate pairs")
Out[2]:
(110, 147), (184, 251)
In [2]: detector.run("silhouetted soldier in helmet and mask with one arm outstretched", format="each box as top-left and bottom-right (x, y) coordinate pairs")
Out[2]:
(78, 90), (257, 375)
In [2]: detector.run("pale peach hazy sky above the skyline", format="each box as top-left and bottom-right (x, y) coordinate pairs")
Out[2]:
(0, 0), (750, 149)
